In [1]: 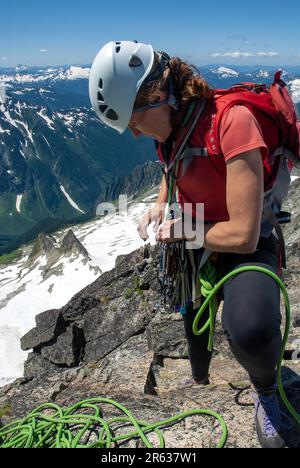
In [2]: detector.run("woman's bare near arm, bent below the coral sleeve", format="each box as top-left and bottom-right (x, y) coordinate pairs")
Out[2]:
(204, 149), (263, 253)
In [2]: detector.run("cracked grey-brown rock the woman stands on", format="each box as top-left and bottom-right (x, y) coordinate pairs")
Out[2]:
(0, 178), (300, 448)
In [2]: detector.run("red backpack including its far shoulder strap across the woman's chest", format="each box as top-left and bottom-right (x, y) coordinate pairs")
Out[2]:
(158, 70), (300, 268)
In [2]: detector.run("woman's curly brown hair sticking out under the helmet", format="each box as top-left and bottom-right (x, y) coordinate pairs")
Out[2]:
(134, 54), (215, 129)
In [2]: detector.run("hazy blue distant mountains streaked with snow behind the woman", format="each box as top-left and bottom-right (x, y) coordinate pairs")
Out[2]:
(0, 65), (300, 253)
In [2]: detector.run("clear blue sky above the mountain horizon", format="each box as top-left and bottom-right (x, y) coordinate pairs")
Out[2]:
(0, 0), (300, 67)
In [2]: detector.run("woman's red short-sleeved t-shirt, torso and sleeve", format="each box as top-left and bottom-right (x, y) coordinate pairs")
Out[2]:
(177, 105), (269, 222)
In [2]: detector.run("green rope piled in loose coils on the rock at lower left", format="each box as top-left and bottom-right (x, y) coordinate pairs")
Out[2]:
(0, 398), (227, 448)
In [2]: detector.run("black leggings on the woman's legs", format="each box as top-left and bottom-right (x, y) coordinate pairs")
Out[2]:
(184, 235), (282, 389)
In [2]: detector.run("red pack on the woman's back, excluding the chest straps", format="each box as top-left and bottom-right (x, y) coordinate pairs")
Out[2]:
(216, 70), (300, 268)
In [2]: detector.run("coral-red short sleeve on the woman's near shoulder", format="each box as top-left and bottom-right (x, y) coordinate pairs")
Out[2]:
(219, 105), (268, 161)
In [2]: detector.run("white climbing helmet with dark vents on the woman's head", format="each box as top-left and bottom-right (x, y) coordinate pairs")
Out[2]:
(89, 41), (154, 133)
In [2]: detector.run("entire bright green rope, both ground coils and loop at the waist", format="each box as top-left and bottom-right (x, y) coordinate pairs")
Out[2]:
(0, 262), (300, 448)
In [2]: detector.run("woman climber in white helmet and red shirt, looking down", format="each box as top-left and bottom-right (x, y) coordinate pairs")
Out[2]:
(89, 41), (298, 448)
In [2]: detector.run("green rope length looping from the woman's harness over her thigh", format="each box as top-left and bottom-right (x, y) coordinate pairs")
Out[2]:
(193, 261), (300, 424)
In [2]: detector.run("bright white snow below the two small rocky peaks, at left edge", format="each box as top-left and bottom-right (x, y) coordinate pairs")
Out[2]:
(0, 255), (100, 387)
